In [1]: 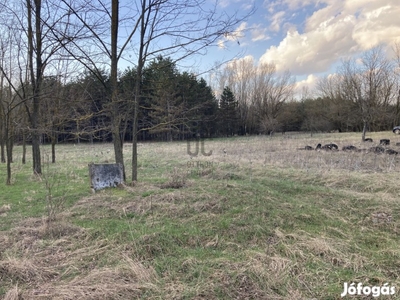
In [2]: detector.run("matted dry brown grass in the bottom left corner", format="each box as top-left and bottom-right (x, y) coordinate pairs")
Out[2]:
(0, 214), (158, 299)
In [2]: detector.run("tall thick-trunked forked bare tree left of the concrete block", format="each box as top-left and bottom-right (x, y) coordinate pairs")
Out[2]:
(0, 0), (72, 174)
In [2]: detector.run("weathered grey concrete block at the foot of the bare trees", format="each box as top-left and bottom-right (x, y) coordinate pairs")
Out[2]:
(89, 164), (124, 191)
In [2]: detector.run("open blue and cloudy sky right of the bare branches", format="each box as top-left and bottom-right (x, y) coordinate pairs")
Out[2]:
(203, 0), (400, 96)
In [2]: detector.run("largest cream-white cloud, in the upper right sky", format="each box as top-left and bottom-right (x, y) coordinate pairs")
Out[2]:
(260, 0), (400, 74)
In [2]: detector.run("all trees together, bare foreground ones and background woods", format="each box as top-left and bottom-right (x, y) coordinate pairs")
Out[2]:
(0, 0), (400, 183)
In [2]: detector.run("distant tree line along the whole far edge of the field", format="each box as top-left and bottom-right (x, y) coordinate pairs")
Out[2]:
(0, 49), (399, 149)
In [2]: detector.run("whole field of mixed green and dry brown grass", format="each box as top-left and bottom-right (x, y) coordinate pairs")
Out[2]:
(0, 132), (400, 300)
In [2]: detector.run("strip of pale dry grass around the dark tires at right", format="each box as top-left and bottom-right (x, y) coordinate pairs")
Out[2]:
(205, 133), (400, 173)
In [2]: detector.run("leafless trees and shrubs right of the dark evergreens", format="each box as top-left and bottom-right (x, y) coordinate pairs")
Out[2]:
(214, 44), (400, 136)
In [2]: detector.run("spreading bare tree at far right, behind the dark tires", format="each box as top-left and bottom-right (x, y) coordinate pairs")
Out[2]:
(317, 46), (400, 141)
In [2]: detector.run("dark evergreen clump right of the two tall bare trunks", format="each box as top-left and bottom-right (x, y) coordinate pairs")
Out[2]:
(134, 56), (217, 140)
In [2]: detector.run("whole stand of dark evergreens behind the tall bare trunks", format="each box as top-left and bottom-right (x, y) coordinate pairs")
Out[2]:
(28, 56), (218, 143)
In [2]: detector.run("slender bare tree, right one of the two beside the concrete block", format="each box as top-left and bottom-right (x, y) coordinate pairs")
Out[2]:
(132, 0), (253, 181)
